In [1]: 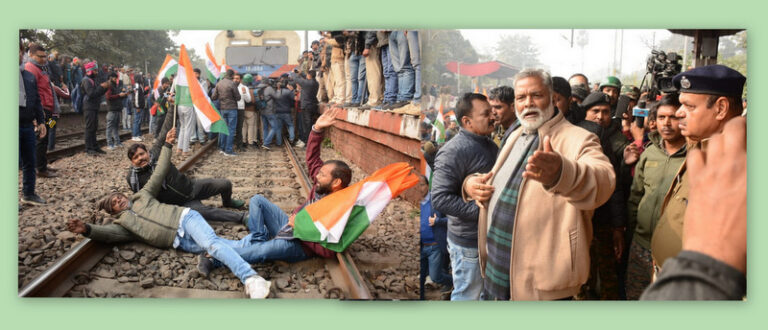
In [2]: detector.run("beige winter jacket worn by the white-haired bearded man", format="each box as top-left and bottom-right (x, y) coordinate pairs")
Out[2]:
(465, 112), (616, 300)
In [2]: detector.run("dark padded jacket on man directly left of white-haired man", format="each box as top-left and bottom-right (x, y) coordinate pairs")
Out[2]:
(432, 128), (499, 247)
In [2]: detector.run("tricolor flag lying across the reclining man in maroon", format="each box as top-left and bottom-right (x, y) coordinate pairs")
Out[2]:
(293, 163), (419, 252)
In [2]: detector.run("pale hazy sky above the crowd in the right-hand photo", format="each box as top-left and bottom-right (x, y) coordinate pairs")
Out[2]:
(461, 30), (682, 80)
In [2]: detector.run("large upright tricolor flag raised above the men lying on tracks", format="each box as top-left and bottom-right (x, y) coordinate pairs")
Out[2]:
(175, 44), (229, 135)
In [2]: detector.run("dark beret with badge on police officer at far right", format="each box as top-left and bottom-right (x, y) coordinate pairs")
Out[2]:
(672, 64), (747, 96)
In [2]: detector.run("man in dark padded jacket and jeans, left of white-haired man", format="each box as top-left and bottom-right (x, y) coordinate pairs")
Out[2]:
(432, 93), (499, 300)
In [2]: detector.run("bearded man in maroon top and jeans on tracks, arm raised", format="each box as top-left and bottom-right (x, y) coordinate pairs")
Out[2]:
(197, 108), (344, 276)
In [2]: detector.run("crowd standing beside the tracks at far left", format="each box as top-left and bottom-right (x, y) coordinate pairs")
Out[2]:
(19, 42), (159, 205)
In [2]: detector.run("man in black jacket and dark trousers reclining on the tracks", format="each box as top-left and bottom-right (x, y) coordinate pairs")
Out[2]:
(126, 109), (248, 222)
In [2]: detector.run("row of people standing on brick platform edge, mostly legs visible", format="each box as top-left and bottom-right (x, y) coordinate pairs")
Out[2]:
(299, 30), (422, 113)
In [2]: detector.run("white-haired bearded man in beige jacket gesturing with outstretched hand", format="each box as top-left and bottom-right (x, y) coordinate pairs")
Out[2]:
(463, 69), (616, 300)
